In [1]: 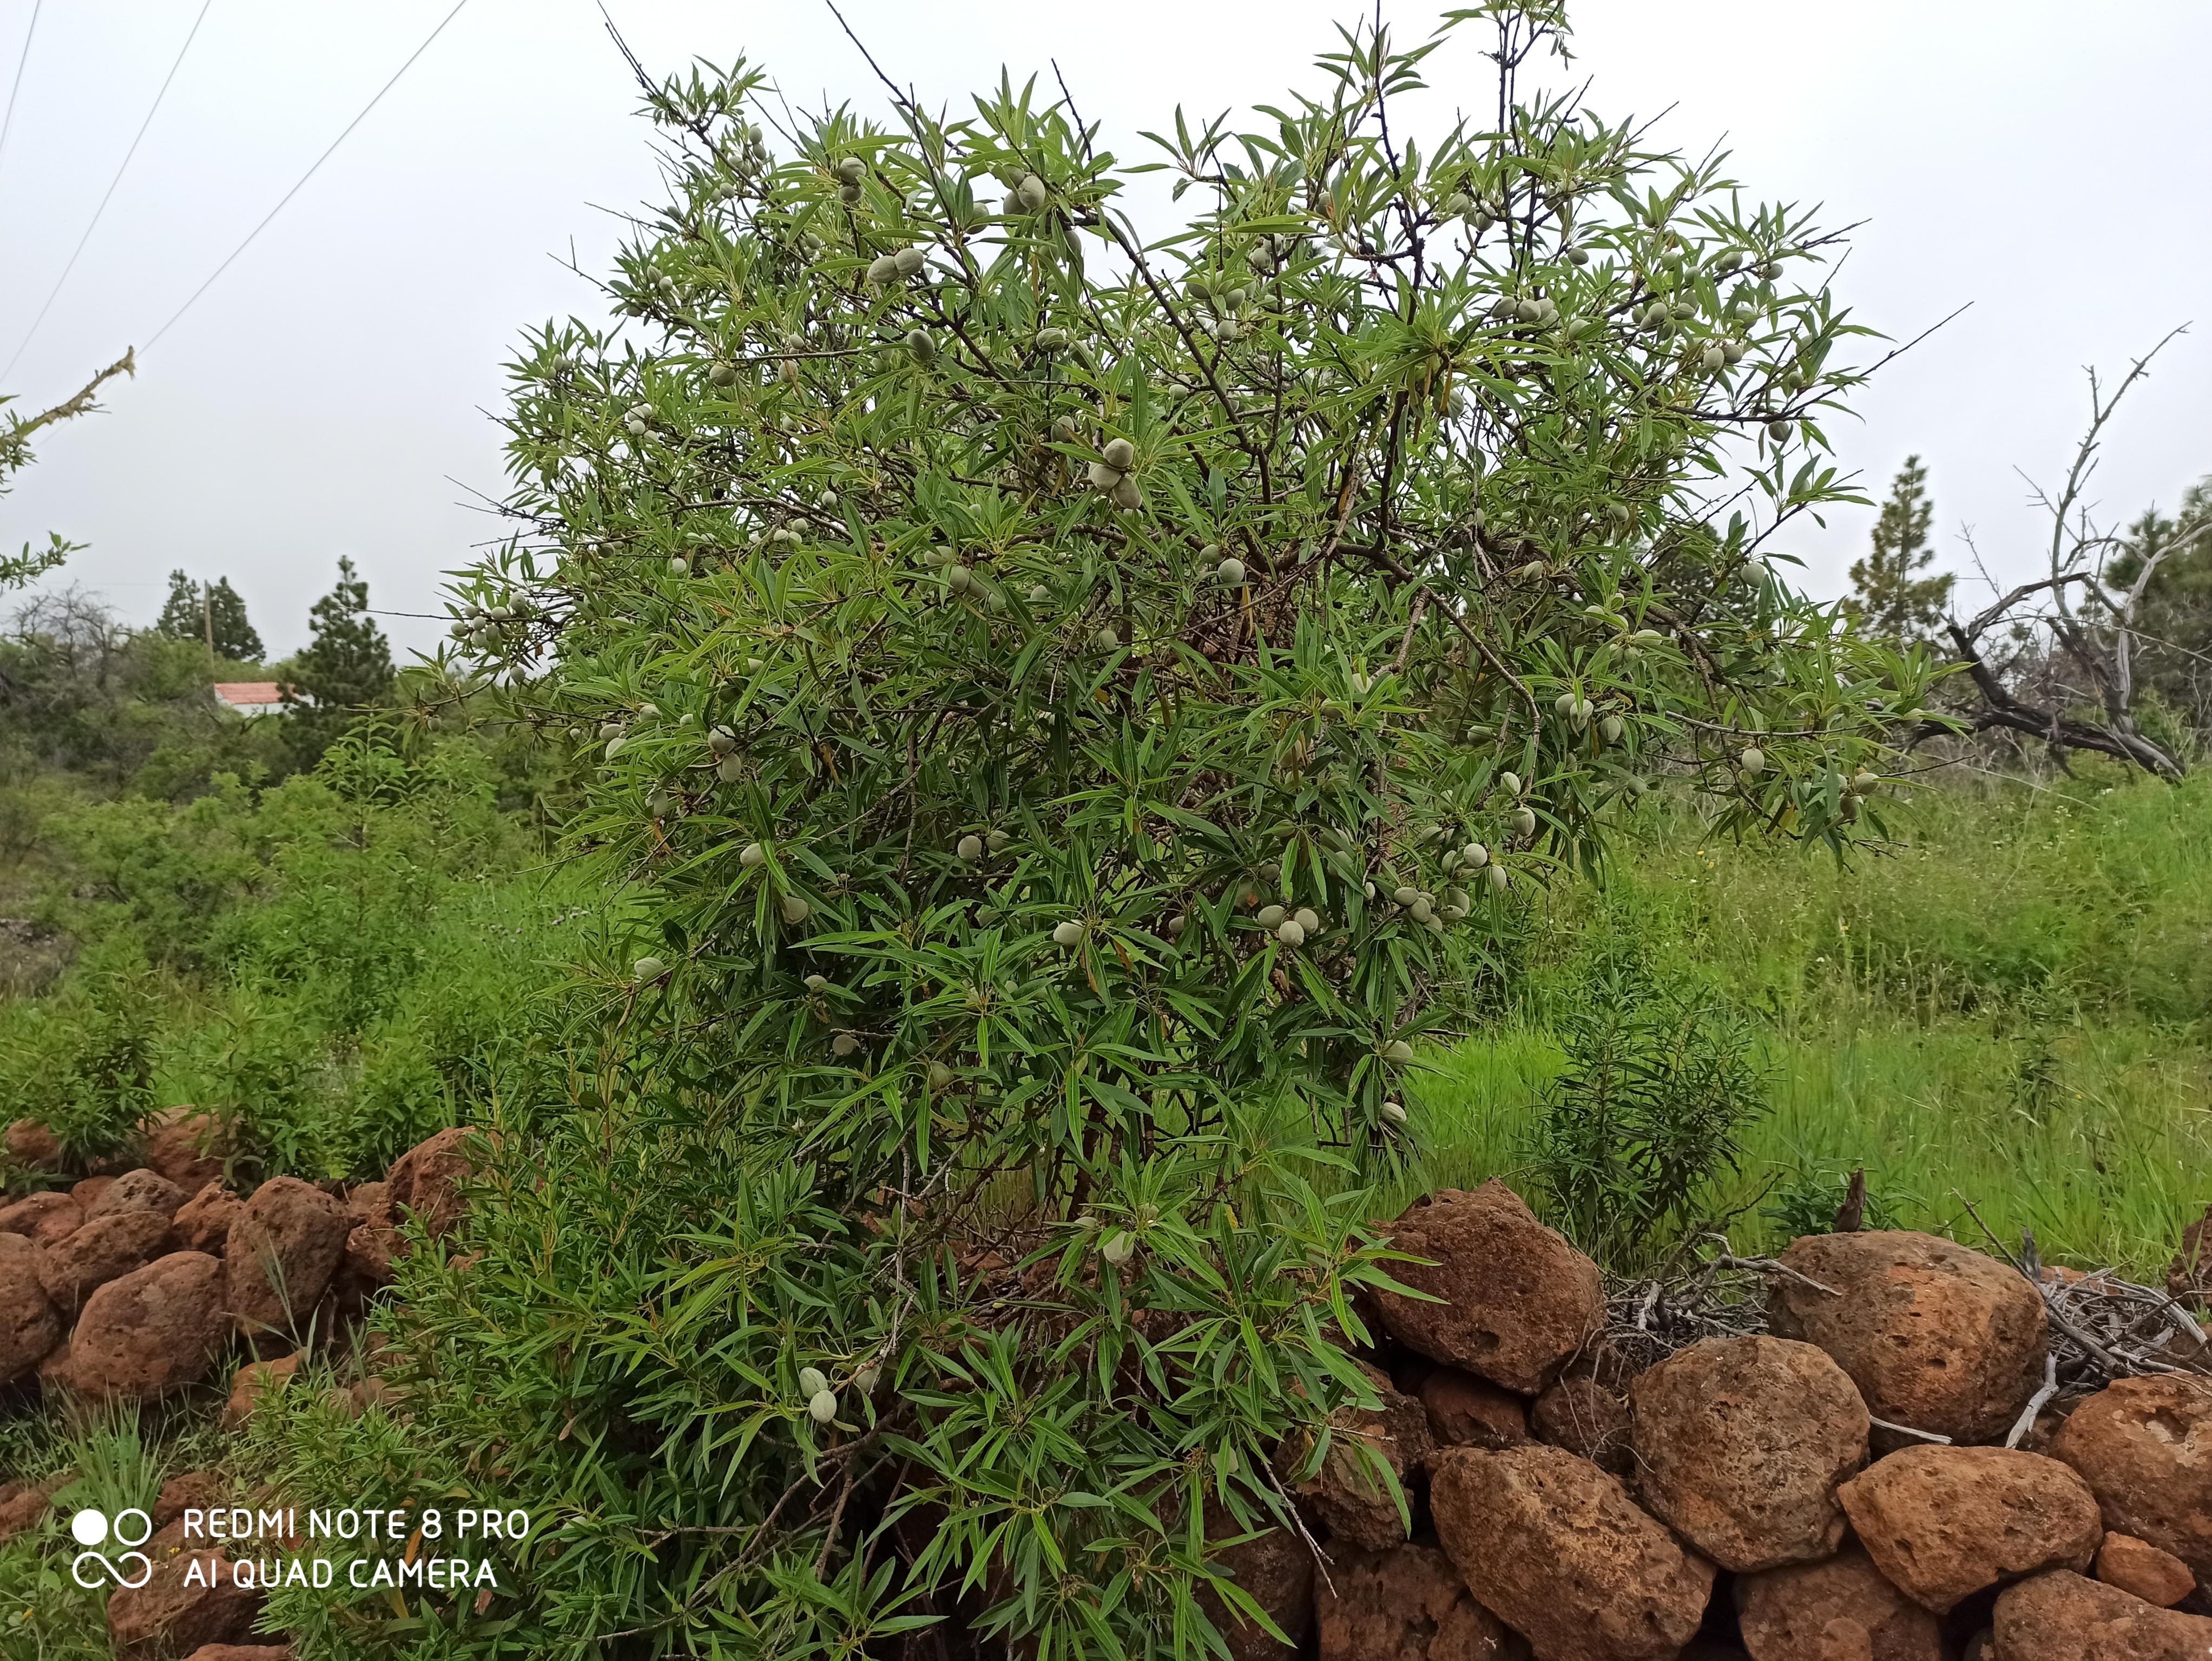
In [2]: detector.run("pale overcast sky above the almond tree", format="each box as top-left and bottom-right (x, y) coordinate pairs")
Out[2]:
(0, 0), (2212, 653)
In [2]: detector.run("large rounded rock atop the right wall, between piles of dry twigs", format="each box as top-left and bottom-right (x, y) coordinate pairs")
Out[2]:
(1767, 1230), (2044, 1447)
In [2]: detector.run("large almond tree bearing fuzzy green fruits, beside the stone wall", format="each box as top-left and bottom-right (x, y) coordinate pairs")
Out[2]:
(272, 6), (1920, 1659)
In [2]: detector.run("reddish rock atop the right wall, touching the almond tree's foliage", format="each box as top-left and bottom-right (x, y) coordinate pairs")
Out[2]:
(1376, 1181), (1606, 1396)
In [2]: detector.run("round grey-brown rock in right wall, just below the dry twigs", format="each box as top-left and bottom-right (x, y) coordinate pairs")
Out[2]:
(1628, 1338), (1867, 1575)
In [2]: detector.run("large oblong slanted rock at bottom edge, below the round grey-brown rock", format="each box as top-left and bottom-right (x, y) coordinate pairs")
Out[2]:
(1429, 1445), (1712, 1661)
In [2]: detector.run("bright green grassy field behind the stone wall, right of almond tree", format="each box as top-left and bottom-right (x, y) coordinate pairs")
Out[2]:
(1416, 770), (2212, 1278)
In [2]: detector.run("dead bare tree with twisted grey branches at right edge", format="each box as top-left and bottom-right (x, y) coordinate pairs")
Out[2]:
(1929, 330), (2212, 778)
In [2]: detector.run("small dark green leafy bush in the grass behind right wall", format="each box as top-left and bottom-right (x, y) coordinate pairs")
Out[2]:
(1531, 973), (1767, 1272)
